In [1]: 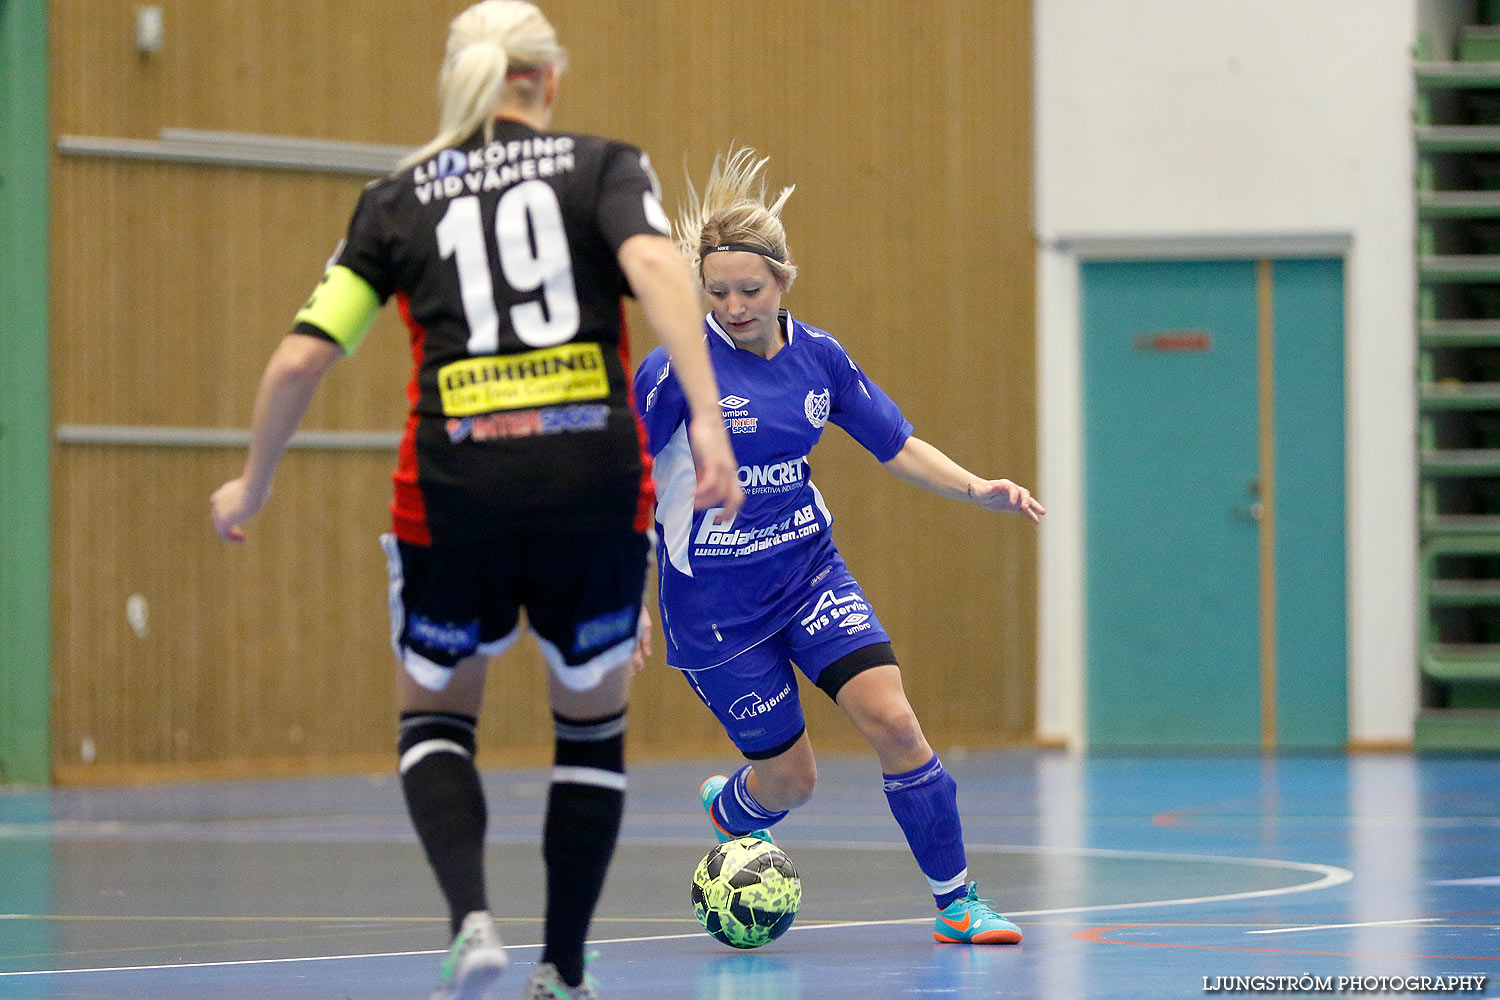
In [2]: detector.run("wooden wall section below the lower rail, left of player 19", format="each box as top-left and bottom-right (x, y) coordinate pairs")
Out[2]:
(54, 447), (395, 778)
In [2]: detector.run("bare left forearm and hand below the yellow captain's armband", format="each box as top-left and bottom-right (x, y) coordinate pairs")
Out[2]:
(209, 333), (344, 541)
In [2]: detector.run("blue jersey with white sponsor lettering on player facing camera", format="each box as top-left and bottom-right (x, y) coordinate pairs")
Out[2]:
(635, 310), (912, 670)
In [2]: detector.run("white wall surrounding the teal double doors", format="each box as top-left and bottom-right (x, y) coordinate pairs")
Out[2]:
(1034, 0), (1418, 747)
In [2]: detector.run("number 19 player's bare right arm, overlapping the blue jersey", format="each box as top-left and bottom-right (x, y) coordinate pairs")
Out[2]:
(620, 232), (744, 514)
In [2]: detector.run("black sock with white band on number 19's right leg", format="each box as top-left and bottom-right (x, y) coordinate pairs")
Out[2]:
(542, 712), (626, 987)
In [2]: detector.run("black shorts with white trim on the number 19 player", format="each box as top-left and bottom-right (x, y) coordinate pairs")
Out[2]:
(381, 531), (648, 690)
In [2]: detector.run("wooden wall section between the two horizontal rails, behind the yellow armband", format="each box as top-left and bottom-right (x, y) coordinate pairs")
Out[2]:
(53, 157), (411, 430)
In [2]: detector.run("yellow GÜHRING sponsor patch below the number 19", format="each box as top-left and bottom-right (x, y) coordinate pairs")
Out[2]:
(438, 343), (609, 417)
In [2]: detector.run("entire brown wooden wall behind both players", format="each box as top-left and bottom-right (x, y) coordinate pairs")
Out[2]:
(50, 0), (1046, 780)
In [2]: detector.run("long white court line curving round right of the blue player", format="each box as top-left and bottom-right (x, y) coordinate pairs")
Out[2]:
(0, 844), (1362, 979)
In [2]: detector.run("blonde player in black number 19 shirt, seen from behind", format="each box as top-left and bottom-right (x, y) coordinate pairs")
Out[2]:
(213, 0), (743, 1000)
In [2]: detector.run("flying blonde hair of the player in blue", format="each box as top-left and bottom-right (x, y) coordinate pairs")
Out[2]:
(672, 147), (797, 292)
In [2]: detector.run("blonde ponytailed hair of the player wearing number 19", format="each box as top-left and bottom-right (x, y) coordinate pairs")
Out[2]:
(401, 0), (567, 168)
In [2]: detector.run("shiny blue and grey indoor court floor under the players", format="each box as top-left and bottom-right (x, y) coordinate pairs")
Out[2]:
(0, 753), (1500, 1000)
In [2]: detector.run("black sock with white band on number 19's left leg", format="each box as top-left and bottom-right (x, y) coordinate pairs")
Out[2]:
(399, 712), (489, 934)
